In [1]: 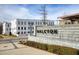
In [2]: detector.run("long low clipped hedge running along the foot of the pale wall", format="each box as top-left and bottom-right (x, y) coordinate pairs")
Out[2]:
(22, 41), (79, 55)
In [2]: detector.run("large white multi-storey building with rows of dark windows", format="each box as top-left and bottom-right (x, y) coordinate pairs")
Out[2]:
(11, 19), (54, 36)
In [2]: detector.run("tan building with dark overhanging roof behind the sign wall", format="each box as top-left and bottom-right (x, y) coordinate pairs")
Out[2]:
(59, 13), (79, 25)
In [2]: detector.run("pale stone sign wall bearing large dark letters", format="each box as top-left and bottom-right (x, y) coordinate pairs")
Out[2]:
(35, 25), (79, 37)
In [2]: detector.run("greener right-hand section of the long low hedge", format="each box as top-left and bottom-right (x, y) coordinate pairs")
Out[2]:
(48, 45), (78, 55)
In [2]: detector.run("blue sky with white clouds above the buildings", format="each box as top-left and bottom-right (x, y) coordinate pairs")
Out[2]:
(0, 4), (79, 21)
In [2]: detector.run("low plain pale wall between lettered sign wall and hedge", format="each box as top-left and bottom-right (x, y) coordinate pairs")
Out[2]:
(28, 36), (79, 49)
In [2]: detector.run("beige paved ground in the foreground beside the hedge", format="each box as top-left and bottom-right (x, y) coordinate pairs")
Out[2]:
(0, 43), (55, 55)
